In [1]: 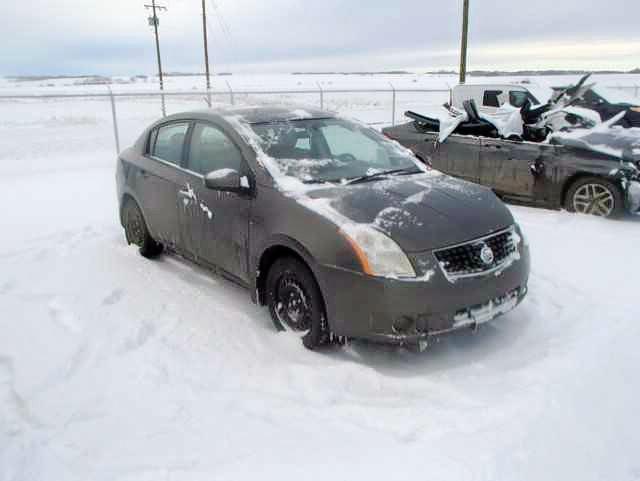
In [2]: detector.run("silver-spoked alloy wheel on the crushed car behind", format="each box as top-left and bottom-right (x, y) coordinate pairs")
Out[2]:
(565, 177), (624, 218)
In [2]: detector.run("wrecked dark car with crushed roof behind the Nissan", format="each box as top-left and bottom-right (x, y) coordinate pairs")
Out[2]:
(383, 106), (640, 217)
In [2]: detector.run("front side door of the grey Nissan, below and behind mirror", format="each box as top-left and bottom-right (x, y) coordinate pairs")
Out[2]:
(185, 122), (251, 282)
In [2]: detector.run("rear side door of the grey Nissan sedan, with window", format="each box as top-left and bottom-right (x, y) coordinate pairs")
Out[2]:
(136, 121), (189, 247)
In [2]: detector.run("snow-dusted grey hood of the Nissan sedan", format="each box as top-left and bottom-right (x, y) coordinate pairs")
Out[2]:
(306, 172), (514, 252)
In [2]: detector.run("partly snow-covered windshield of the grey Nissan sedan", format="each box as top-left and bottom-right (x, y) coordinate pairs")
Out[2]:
(251, 119), (421, 183)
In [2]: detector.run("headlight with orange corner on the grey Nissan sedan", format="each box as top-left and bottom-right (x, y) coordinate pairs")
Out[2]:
(340, 224), (416, 278)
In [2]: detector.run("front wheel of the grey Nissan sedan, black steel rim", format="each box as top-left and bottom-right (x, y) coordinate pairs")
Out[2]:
(266, 257), (329, 350)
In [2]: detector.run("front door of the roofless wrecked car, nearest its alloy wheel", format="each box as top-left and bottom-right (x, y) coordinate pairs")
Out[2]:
(480, 138), (554, 201)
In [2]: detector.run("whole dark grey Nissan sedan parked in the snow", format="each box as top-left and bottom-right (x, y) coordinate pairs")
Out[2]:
(116, 107), (529, 349)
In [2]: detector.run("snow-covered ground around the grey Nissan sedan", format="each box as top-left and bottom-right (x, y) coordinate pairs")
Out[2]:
(0, 73), (640, 481)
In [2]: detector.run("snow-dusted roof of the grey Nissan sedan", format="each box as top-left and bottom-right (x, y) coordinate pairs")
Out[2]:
(165, 106), (335, 124)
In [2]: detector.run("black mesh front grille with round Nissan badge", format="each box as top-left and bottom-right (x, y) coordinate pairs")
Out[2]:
(434, 227), (520, 281)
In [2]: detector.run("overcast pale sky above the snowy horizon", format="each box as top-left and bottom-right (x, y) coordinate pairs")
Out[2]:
(0, 0), (640, 75)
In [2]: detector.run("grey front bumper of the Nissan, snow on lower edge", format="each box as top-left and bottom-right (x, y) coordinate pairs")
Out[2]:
(320, 245), (530, 345)
